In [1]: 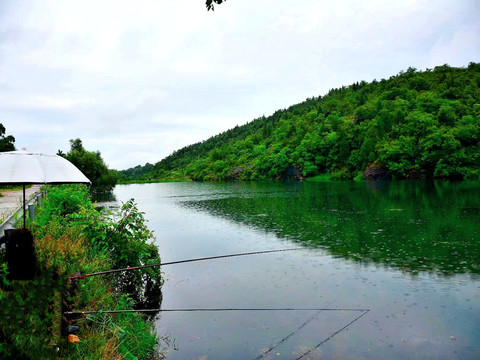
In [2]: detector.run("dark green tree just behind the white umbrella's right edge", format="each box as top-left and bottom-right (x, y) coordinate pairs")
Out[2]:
(59, 139), (118, 193)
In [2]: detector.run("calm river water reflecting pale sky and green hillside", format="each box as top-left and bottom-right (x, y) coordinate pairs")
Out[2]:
(115, 181), (480, 360)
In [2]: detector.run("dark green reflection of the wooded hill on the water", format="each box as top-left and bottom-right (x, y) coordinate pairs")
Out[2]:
(181, 181), (480, 276)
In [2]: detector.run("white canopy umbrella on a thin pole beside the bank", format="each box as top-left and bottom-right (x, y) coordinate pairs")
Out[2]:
(0, 151), (91, 227)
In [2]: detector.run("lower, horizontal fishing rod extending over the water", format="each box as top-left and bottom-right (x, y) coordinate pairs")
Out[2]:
(63, 308), (370, 316)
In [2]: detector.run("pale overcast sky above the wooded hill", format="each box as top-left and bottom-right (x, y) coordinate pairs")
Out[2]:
(0, 0), (480, 170)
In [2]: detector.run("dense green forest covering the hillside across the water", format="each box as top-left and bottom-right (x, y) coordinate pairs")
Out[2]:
(119, 63), (480, 181)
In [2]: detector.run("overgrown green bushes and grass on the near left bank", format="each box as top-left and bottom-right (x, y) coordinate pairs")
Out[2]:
(0, 185), (162, 360)
